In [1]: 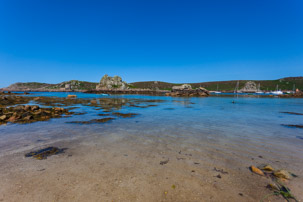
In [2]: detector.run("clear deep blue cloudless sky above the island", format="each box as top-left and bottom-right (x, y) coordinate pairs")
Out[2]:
(0, 0), (303, 87)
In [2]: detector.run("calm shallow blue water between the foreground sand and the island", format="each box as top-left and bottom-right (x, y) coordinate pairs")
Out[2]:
(0, 93), (303, 169)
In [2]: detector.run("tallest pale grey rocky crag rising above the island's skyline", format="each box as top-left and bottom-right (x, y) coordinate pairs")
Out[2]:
(96, 74), (128, 90)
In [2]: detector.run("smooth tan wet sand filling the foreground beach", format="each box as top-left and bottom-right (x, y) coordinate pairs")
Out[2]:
(0, 130), (303, 201)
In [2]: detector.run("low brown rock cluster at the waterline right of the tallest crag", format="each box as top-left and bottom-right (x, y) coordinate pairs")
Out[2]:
(166, 87), (209, 97)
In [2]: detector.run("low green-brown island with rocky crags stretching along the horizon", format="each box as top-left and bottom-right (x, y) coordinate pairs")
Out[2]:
(1, 75), (303, 92)
